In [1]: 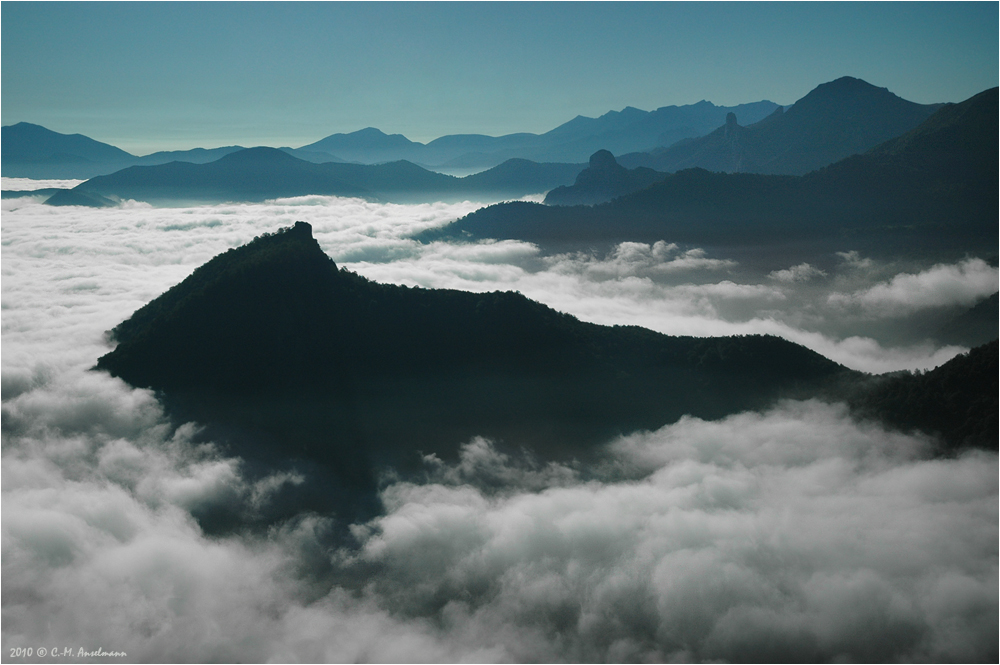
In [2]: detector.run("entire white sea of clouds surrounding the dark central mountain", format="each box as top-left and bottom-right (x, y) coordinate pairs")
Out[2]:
(2, 192), (998, 662)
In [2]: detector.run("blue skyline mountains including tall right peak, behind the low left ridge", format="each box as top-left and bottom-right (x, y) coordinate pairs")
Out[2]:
(2, 77), (960, 184)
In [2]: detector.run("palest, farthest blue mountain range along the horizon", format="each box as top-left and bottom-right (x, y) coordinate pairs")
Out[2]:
(0, 94), (778, 179)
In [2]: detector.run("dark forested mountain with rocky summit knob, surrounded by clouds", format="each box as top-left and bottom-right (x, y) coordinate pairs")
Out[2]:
(97, 222), (850, 520)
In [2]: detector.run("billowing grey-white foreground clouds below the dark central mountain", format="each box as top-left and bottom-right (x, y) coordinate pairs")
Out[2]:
(3, 375), (998, 662)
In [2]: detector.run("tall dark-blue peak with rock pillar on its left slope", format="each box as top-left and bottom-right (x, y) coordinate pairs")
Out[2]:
(619, 76), (940, 175)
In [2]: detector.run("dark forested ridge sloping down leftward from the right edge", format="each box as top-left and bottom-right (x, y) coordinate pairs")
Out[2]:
(426, 83), (998, 255)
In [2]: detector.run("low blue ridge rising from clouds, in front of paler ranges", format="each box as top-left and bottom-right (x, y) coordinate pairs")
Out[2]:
(62, 148), (582, 203)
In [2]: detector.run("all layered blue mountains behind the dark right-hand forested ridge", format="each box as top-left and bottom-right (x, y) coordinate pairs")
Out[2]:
(3, 77), (972, 206)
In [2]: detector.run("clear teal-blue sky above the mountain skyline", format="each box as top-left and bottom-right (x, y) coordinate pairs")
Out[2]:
(0, 2), (1000, 154)
